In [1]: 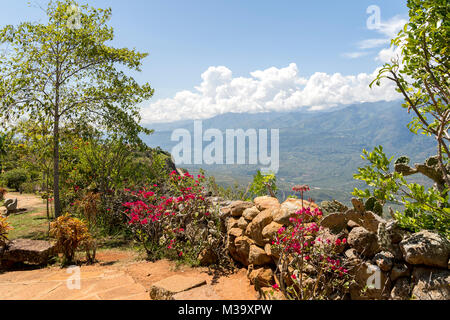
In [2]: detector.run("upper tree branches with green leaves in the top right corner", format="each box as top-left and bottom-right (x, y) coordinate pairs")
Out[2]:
(371, 0), (450, 188)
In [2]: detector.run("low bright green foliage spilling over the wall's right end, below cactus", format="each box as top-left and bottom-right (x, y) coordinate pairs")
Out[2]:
(352, 146), (450, 237)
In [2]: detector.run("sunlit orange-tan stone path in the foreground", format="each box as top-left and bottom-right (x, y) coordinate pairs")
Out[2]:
(0, 251), (257, 300)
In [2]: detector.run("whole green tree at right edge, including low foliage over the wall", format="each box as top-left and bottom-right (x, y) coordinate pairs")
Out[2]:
(353, 0), (450, 238)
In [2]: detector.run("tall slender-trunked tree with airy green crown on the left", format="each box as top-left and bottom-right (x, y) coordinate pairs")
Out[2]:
(0, 0), (153, 216)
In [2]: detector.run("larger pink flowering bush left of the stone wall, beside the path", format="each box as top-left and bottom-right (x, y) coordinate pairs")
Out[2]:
(123, 171), (225, 260)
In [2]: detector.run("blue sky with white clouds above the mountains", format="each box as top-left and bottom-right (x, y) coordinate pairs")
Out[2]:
(0, 0), (407, 121)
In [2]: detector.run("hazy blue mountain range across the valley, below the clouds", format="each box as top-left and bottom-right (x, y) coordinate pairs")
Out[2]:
(144, 101), (436, 201)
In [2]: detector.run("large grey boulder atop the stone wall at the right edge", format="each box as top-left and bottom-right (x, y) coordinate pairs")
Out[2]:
(400, 230), (450, 268)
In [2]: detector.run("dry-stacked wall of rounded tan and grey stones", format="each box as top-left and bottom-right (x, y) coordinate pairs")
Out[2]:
(220, 196), (450, 300)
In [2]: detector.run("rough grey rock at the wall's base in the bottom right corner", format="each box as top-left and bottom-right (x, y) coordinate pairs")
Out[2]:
(412, 267), (450, 300)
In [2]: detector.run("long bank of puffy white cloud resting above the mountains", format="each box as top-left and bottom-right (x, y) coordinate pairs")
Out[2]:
(142, 63), (399, 124)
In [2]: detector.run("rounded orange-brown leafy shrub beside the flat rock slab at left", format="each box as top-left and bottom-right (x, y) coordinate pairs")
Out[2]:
(50, 213), (95, 263)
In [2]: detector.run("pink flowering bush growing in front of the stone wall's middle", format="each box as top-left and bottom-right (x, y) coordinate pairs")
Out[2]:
(272, 208), (351, 300)
